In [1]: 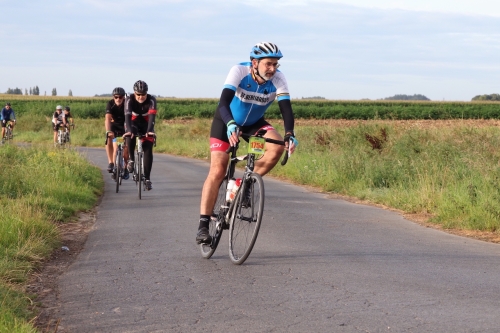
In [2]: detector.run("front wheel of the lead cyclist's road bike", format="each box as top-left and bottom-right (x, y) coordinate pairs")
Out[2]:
(229, 173), (265, 265)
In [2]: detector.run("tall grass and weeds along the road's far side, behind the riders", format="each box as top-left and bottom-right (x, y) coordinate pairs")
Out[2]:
(12, 116), (500, 232)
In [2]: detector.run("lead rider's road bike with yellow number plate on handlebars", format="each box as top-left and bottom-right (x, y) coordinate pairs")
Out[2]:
(200, 130), (288, 265)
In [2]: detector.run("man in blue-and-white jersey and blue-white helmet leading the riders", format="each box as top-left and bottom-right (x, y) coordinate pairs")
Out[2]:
(196, 43), (298, 244)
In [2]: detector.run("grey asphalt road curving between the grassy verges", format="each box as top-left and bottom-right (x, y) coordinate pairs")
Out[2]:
(59, 149), (500, 333)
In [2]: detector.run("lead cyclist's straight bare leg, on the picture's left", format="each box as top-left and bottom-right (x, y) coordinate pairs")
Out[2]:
(200, 151), (229, 215)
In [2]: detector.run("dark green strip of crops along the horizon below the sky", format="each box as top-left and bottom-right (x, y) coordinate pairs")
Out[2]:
(0, 95), (500, 120)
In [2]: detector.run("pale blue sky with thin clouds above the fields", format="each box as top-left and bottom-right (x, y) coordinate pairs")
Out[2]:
(0, 0), (500, 101)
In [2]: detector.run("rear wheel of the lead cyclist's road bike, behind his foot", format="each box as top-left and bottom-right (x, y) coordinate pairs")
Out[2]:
(200, 178), (227, 259)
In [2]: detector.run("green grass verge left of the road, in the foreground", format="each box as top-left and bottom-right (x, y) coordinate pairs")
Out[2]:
(0, 145), (103, 333)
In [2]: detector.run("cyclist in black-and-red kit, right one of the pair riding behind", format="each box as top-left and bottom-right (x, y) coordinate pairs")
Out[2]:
(125, 80), (156, 191)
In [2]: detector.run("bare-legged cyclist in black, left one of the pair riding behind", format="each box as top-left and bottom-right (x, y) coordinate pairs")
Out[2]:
(104, 87), (129, 179)
